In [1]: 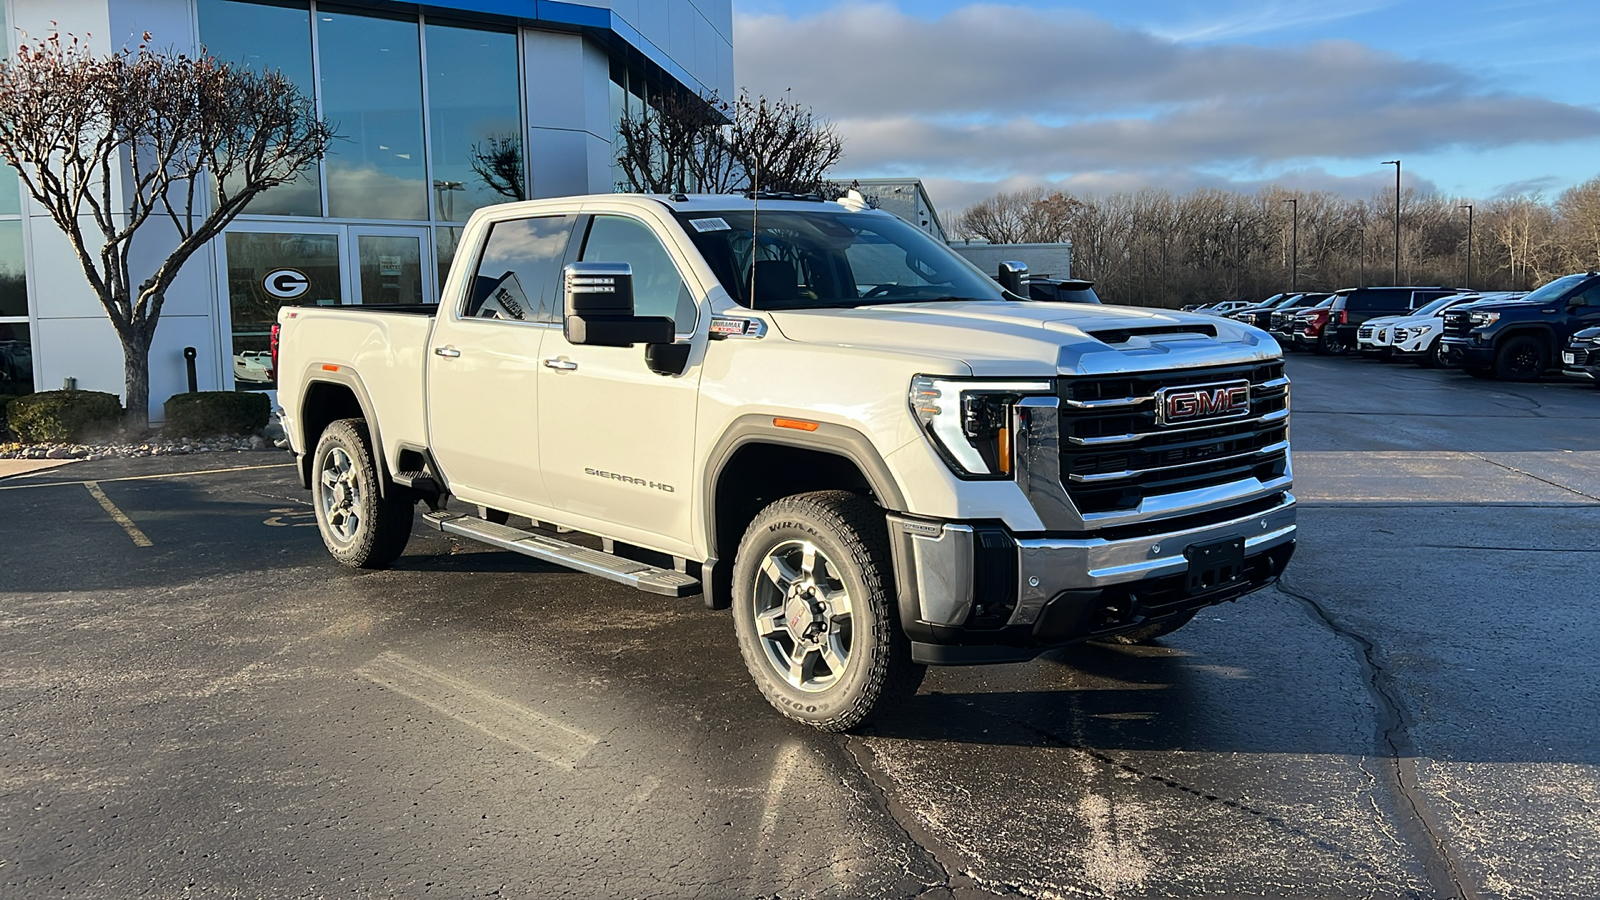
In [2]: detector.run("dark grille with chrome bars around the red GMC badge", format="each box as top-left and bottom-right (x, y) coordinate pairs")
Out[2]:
(1061, 360), (1288, 514)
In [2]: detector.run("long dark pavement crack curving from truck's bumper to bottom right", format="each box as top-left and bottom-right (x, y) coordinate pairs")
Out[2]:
(1278, 578), (1483, 900)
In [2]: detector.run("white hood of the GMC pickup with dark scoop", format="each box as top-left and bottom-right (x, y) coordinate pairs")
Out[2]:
(771, 299), (1278, 376)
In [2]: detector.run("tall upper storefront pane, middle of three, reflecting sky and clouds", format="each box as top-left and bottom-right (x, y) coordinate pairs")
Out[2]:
(317, 6), (427, 219)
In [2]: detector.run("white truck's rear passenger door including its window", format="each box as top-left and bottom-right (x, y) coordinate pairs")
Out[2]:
(427, 209), (578, 509)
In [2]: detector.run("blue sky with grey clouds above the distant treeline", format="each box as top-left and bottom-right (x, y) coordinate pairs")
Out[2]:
(733, 0), (1600, 215)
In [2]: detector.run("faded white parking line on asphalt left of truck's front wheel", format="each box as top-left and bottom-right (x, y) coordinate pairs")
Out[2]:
(355, 652), (600, 770)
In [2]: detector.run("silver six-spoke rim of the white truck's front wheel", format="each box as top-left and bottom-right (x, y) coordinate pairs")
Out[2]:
(750, 541), (854, 693)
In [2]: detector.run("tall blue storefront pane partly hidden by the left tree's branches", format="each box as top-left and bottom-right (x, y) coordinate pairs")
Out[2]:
(198, 0), (322, 216)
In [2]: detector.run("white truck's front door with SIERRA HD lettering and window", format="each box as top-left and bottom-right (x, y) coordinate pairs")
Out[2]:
(539, 216), (701, 556)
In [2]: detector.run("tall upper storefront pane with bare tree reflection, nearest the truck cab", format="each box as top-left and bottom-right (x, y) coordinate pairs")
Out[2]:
(424, 24), (528, 223)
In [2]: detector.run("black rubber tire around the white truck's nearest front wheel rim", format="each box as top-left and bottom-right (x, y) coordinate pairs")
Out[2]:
(733, 490), (926, 732)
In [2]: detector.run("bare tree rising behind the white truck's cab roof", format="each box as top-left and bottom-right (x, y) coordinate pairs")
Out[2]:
(618, 91), (843, 194)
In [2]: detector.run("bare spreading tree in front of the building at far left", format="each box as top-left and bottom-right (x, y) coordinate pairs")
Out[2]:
(0, 34), (333, 431)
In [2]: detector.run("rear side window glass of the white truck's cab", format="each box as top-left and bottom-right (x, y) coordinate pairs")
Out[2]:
(461, 216), (574, 322)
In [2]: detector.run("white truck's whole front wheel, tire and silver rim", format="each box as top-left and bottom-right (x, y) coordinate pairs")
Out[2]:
(733, 490), (926, 732)
